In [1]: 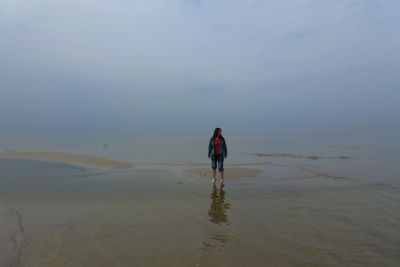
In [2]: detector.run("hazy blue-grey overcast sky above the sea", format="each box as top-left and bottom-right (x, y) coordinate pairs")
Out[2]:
(0, 0), (400, 125)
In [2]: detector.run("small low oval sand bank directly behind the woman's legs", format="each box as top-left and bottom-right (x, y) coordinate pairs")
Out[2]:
(183, 167), (262, 179)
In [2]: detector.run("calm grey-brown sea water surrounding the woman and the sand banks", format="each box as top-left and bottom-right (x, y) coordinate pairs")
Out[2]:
(0, 127), (400, 266)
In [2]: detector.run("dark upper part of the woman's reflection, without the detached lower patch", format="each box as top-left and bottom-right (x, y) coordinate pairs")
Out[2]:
(208, 183), (230, 224)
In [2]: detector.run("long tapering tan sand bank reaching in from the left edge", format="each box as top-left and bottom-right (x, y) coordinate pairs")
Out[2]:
(0, 151), (133, 169)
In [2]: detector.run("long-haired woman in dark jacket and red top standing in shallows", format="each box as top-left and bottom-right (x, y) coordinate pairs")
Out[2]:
(208, 128), (228, 183)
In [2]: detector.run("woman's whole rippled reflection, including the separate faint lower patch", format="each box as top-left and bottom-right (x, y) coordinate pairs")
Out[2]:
(201, 183), (230, 251)
